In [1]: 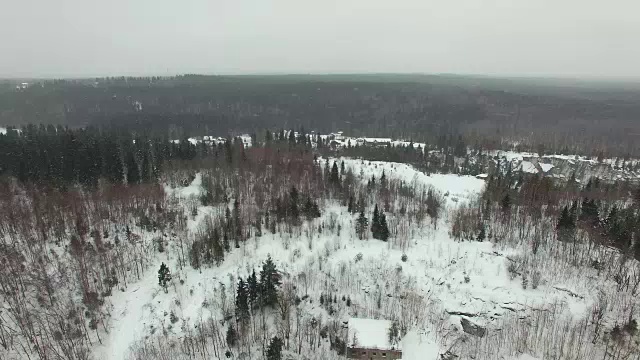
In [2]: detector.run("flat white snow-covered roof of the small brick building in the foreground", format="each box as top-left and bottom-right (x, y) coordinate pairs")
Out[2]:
(349, 318), (398, 350)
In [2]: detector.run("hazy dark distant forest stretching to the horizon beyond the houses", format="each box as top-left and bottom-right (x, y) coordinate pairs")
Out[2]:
(0, 75), (640, 155)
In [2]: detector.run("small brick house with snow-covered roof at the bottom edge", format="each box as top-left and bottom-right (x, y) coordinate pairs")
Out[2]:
(347, 318), (402, 360)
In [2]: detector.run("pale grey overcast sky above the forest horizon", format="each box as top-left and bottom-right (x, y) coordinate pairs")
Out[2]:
(0, 0), (640, 78)
